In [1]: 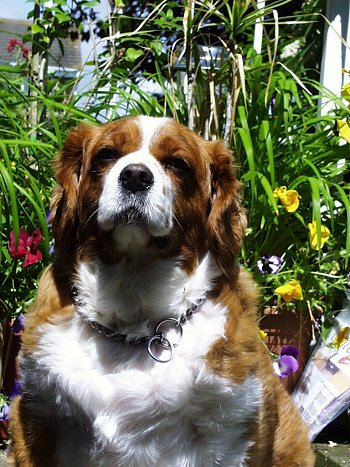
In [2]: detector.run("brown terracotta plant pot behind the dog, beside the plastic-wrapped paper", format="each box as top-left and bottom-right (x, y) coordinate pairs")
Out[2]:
(259, 307), (312, 393)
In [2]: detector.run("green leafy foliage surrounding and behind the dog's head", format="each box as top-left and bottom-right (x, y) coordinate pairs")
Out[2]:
(0, 0), (350, 326)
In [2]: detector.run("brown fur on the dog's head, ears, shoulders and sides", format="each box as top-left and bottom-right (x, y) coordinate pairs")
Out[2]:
(11, 119), (314, 467)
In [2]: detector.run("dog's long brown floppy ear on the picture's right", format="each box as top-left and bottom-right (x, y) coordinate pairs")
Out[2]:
(206, 141), (247, 277)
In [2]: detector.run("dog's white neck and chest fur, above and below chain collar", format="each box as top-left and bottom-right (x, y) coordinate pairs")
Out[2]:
(22, 254), (261, 467)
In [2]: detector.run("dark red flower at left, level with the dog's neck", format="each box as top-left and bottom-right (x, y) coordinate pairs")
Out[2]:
(8, 229), (43, 268)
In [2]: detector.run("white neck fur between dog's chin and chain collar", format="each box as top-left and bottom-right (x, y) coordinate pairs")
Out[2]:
(76, 253), (220, 334)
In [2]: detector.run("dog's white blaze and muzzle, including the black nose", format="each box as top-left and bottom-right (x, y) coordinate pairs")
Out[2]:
(97, 118), (175, 246)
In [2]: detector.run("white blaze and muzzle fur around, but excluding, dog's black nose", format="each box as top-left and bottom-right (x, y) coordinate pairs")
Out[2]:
(97, 117), (174, 243)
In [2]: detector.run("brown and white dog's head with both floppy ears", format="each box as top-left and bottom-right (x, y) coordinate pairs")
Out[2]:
(51, 117), (246, 275)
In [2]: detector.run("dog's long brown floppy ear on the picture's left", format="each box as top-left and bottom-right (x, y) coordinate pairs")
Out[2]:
(48, 124), (95, 249)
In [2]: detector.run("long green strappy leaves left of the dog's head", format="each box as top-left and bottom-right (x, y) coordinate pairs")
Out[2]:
(0, 66), (97, 319)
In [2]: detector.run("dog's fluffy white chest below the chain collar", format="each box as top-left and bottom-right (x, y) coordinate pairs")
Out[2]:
(27, 307), (261, 467)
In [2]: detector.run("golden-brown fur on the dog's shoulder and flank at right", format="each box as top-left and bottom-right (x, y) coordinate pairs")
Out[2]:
(207, 269), (315, 467)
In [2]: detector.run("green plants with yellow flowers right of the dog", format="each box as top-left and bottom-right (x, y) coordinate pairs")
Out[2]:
(235, 63), (350, 340)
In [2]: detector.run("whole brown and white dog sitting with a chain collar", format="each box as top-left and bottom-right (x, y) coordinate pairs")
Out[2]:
(11, 117), (314, 467)
